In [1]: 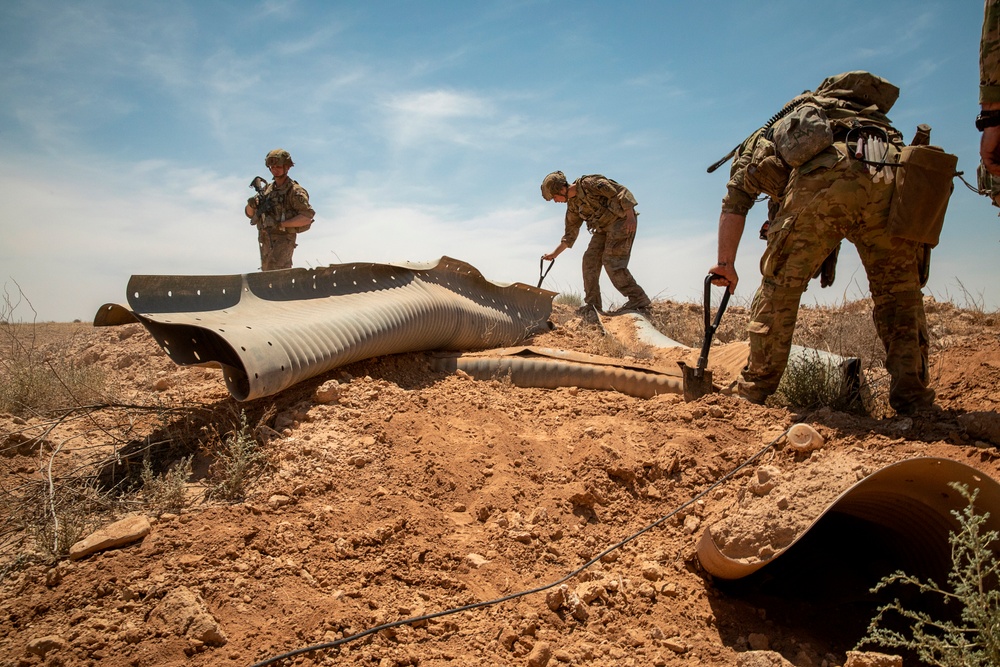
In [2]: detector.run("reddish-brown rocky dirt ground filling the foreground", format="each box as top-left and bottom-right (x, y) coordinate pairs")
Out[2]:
(0, 304), (1000, 667)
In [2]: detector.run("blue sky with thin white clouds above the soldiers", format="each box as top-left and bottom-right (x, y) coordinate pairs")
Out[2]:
(0, 0), (1000, 321)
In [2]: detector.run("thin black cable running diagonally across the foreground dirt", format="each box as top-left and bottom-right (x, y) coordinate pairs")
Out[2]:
(250, 429), (788, 667)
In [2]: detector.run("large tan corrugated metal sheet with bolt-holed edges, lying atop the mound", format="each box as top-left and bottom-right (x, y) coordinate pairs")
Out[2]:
(94, 257), (555, 401)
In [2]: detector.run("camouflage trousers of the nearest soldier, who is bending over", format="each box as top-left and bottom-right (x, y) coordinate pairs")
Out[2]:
(739, 151), (934, 411)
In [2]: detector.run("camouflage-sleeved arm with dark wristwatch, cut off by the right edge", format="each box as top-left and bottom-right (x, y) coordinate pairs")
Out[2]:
(976, 0), (1000, 177)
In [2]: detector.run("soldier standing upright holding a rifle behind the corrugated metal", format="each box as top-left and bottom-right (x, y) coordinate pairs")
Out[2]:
(245, 148), (316, 271)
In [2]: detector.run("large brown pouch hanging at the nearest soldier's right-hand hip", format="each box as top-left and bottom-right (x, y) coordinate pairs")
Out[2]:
(889, 146), (958, 248)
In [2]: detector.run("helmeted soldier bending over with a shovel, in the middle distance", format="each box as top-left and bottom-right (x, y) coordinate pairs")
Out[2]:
(542, 171), (650, 322)
